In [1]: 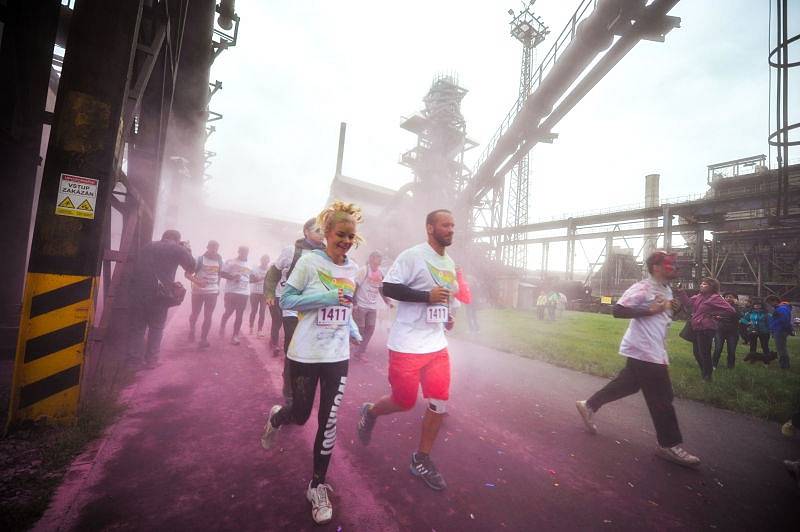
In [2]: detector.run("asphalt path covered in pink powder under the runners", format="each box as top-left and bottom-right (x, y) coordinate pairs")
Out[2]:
(37, 309), (800, 531)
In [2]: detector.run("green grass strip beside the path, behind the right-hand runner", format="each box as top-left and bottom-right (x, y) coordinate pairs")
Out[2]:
(456, 309), (800, 421)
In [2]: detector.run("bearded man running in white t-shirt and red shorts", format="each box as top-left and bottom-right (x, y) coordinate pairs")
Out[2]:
(358, 209), (458, 490)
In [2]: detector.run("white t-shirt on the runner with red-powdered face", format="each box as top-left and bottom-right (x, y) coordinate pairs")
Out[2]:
(617, 277), (672, 364)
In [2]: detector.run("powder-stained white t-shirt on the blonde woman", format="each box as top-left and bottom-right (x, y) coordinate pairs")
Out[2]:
(286, 251), (358, 363)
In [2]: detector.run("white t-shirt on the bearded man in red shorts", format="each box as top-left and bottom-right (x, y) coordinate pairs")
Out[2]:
(383, 242), (458, 354)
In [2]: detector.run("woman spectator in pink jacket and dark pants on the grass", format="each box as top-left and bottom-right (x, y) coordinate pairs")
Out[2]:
(677, 277), (736, 381)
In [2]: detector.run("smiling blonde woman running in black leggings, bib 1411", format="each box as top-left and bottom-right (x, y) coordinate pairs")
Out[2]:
(261, 201), (361, 524)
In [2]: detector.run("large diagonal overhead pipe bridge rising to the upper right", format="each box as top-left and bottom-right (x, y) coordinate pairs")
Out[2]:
(460, 0), (680, 261)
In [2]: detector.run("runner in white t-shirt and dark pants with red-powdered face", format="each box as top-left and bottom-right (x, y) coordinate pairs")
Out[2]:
(576, 251), (700, 467)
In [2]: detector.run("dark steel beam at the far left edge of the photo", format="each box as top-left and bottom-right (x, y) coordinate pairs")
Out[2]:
(0, 0), (60, 392)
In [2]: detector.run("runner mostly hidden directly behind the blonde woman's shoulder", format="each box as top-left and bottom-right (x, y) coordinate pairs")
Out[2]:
(264, 218), (324, 402)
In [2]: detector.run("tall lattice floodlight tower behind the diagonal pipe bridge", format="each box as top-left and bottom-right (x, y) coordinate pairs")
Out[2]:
(502, 0), (550, 270)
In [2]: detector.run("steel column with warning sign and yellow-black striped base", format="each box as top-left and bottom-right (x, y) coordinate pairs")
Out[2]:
(9, 0), (142, 421)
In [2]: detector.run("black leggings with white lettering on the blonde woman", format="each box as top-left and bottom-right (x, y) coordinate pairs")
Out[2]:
(272, 360), (349, 487)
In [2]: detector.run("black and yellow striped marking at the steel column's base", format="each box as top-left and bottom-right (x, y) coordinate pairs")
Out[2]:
(9, 273), (95, 421)
